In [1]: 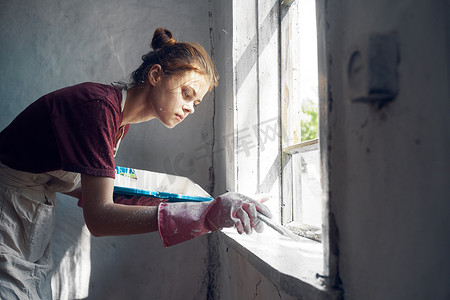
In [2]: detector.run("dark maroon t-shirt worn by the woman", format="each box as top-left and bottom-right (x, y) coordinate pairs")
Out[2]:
(0, 83), (129, 178)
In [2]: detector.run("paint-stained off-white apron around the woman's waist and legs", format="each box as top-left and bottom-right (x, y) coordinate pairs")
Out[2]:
(0, 163), (80, 299)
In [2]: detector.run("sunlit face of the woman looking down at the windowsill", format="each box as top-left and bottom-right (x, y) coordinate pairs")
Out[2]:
(152, 71), (208, 128)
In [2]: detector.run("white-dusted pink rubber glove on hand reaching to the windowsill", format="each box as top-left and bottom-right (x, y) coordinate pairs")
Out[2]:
(158, 193), (272, 247)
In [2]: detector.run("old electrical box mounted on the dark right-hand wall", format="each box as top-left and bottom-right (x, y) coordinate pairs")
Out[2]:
(346, 32), (400, 103)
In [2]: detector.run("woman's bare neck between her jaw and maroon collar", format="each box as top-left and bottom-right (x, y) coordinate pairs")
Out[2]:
(121, 84), (156, 126)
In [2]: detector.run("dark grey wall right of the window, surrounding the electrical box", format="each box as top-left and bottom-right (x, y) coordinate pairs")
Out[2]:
(322, 0), (450, 300)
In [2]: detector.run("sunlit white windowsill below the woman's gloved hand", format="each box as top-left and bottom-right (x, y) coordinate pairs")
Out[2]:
(220, 226), (329, 299)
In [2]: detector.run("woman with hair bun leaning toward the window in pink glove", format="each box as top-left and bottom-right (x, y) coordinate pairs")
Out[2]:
(0, 28), (270, 299)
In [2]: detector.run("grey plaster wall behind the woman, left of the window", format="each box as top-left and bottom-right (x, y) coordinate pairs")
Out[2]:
(0, 0), (214, 299)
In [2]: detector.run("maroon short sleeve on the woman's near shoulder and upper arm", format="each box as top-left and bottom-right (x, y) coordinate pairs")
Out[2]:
(53, 99), (120, 178)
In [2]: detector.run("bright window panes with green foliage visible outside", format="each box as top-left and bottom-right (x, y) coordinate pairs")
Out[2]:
(281, 0), (322, 240)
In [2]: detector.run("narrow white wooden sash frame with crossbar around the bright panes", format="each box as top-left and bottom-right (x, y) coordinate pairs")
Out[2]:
(280, 0), (323, 242)
